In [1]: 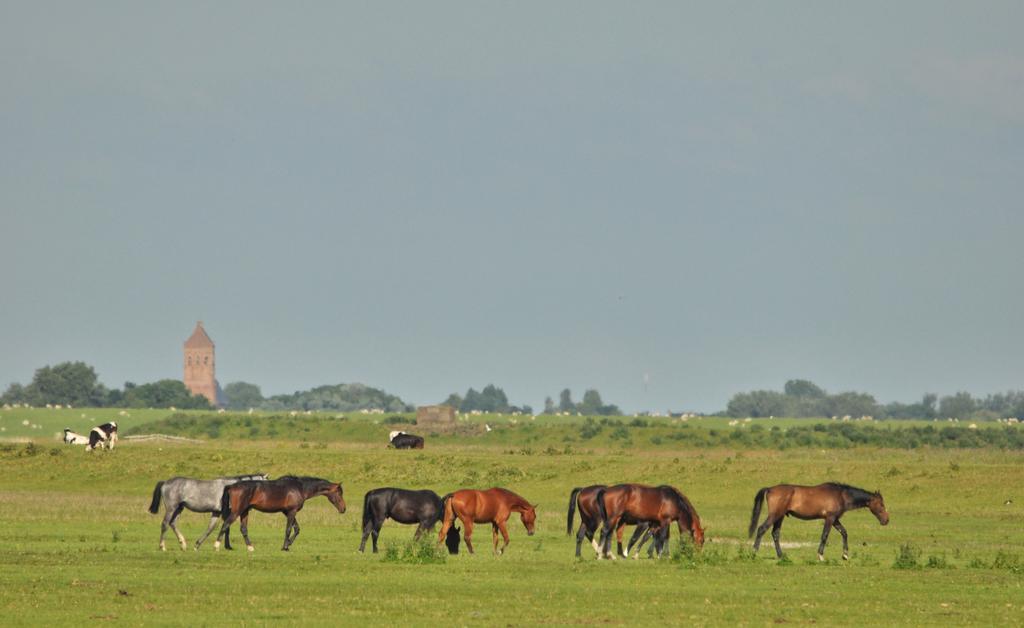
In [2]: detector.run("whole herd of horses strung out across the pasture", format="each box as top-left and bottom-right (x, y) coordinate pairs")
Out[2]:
(150, 473), (889, 560)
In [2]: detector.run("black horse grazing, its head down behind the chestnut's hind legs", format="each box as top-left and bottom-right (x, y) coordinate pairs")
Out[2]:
(359, 488), (459, 554)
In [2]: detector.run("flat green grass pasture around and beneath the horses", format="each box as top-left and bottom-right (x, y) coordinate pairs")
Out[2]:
(0, 410), (1024, 625)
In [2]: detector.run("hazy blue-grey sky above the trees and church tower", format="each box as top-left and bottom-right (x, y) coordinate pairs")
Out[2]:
(0, 1), (1024, 412)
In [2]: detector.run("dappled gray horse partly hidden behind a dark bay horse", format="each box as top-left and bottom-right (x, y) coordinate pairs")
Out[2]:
(150, 473), (268, 551)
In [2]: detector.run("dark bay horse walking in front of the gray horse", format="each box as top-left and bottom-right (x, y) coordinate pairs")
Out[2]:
(213, 475), (345, 551)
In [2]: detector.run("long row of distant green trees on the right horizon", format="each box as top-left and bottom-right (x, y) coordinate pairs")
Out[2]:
(721, 379), (1024, 421)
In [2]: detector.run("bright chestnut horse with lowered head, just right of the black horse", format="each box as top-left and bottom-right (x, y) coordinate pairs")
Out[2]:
(437, 489), (537, 555)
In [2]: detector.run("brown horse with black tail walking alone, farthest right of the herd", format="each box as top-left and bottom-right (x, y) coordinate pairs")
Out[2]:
(748, 482), (889, 560)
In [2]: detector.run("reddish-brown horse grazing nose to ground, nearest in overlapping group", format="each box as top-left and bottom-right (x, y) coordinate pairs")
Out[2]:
(597, 484), (703, 557)
